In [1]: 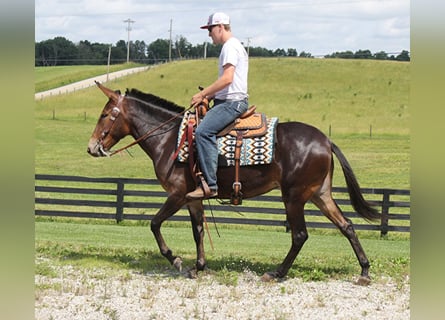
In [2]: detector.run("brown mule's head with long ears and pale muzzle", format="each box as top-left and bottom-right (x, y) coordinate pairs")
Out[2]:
(87, 81), (129, 157)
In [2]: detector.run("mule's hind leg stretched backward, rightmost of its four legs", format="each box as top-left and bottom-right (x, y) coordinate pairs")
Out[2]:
(311, 191), (371, 285)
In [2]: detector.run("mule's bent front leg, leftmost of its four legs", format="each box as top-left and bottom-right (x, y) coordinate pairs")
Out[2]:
(150, 196), (185, 271)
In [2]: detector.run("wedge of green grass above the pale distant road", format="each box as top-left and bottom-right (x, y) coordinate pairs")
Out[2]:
(34, 63), (142, 92)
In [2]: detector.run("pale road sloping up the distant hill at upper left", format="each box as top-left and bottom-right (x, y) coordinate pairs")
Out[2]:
(34, 66), (150, 100)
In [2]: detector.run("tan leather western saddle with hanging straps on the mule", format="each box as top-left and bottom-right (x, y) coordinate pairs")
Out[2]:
(174, 104), (267, 205)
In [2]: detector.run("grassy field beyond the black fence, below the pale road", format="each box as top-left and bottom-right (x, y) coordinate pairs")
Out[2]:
(35, 58), (410, 189)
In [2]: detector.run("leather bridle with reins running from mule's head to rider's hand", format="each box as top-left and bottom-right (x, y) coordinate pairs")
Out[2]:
(97, 95), (192, 157)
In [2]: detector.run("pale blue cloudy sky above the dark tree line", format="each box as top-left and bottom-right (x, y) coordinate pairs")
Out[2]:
(35, 0), (410, 56)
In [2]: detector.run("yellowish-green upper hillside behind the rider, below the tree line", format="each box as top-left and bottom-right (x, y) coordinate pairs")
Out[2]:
(99, 58), (410, 134)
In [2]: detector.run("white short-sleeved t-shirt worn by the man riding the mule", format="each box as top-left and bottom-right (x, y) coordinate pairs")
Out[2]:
(215, 37), (249, 100)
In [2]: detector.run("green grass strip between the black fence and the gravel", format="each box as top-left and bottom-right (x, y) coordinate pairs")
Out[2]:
(36, 221), (410, 282)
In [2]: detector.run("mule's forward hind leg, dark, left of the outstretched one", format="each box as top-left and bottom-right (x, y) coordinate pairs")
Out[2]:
(261, 202), (308, 281)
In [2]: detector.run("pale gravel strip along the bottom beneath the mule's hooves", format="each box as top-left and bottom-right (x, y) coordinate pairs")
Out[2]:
(35, 266), (410, 320)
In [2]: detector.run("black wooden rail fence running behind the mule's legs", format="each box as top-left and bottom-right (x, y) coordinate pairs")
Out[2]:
(34, 174), (410, 236)
